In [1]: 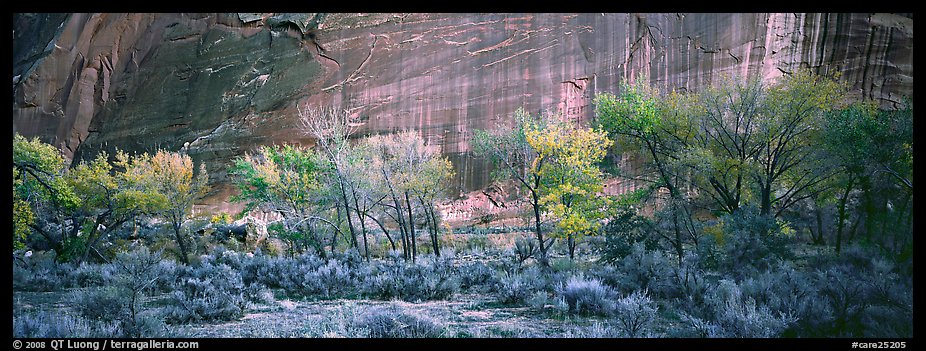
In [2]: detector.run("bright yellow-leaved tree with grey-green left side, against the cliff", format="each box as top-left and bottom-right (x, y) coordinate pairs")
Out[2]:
(473, 109), (612, 265)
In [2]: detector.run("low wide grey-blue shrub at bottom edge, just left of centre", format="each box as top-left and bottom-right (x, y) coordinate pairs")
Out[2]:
(358, 307), (446, 338)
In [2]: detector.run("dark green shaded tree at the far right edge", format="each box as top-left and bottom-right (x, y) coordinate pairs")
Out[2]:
(821, 101), (913, 252)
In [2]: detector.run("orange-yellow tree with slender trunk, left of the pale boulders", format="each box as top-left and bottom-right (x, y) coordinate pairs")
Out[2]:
(122, 150), (209, 264)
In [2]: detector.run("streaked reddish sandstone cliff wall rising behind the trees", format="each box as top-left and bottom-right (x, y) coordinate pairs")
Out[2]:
(13, 14), (913, 213)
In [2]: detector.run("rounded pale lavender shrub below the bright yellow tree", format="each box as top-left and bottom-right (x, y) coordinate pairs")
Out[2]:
(560, 277), (616, 316)
